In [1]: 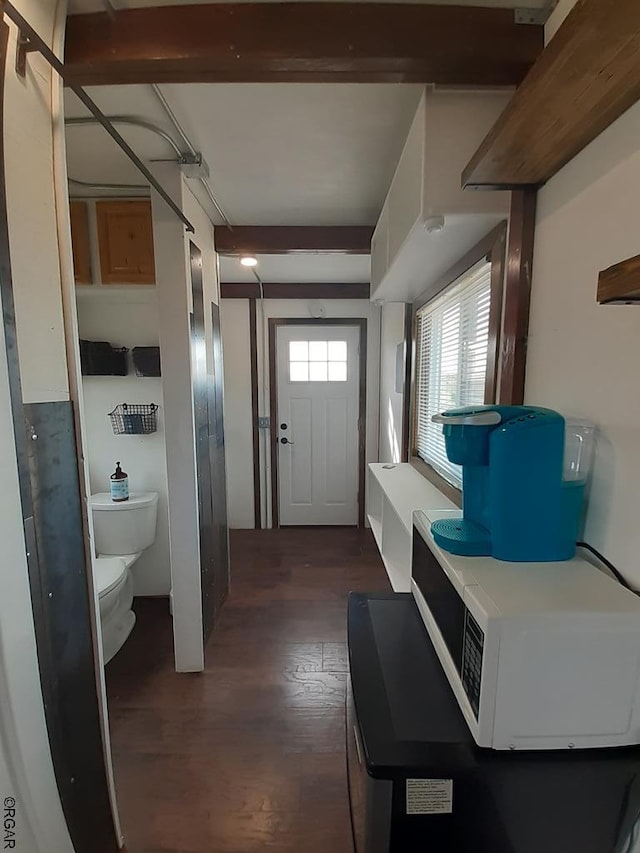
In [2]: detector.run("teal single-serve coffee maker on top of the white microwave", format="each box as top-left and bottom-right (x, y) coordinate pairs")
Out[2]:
(431, 406), (594, 562)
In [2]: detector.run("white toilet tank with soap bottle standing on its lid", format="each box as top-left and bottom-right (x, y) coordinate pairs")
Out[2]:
(91, 492), (158, 556)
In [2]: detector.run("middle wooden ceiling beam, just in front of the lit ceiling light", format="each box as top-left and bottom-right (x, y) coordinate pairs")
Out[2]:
(215, 225), (373, 255)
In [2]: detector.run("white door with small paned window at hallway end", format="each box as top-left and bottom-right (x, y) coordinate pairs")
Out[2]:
(273, 324), (360, 525)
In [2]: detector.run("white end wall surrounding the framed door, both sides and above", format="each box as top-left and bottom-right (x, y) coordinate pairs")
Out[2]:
(222, 299), (380, 527)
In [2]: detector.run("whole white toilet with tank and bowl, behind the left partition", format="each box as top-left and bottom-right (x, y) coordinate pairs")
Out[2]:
(91, 492), (158, 663)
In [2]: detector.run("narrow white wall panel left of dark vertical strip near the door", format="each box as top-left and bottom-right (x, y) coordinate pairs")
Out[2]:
(220, 299), (255, 529)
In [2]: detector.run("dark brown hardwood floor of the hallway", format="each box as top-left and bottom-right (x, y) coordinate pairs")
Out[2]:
(107, 528), (389, 853)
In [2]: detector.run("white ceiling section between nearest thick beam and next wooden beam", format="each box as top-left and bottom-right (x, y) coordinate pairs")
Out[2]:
(66, 83), (421, 225)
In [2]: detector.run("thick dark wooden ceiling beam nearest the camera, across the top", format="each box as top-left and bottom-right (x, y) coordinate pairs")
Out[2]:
(65, 2), (543, 86)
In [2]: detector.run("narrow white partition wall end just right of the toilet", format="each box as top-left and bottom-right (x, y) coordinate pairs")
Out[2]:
(151, 168), (218, 672)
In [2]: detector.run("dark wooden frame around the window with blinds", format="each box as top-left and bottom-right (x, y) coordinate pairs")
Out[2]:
(409, 222), (507, 506)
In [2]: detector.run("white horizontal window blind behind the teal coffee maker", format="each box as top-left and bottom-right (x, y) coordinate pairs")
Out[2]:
(415, 260), (491, 488)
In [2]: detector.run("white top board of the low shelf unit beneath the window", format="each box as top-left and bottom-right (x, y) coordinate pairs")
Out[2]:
(369, 462), (457, 534)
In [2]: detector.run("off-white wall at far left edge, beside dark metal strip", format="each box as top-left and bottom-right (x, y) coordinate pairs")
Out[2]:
(0, 0), (87, 853)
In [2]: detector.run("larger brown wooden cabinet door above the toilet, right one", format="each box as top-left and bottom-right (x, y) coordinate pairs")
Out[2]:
(96, 199), (156, 284)
